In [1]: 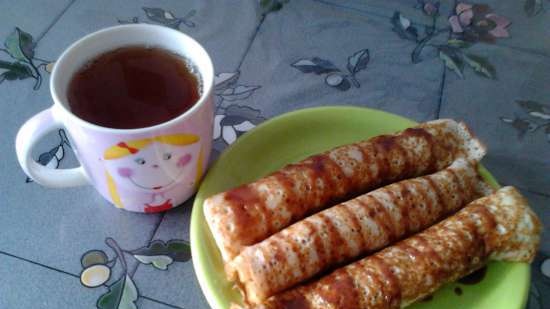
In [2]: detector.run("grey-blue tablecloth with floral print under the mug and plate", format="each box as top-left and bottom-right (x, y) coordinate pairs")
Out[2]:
(0, 0), (550, 309)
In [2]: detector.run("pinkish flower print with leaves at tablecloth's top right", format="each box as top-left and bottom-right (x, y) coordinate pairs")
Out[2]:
(391, 0), (511, 79)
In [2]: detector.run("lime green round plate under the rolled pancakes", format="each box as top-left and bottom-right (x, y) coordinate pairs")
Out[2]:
(191, 106), (530, 309)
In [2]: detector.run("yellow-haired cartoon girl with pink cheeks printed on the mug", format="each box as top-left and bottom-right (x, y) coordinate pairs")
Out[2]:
(103, 134), (202, 212)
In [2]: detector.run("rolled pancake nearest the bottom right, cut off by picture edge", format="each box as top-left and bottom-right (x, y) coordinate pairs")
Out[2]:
(246, 187), (541, 309)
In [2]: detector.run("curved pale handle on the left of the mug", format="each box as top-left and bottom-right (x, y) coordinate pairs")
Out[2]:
(15, 108), (89, 188)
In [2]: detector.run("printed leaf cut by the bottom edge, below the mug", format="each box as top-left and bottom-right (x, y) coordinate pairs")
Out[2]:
(97, 275), (138, 309)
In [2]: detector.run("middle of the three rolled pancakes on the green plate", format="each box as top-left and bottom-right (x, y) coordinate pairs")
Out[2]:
(231, 159), (493, 304)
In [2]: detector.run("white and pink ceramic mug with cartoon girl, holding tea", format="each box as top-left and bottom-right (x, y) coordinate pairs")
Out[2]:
(16, 24), (214, 213)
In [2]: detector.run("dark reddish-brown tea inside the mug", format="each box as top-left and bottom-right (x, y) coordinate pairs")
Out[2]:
(67, 46), (200, 129)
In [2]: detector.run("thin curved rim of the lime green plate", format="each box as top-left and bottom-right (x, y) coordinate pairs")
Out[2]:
(189, 105), (531, 309)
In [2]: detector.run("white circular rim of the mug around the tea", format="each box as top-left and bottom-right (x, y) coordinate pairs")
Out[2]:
(50, 24), (215, 134)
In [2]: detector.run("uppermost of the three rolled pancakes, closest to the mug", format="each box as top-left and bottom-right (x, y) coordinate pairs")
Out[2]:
(204, 119), (485, 262)
